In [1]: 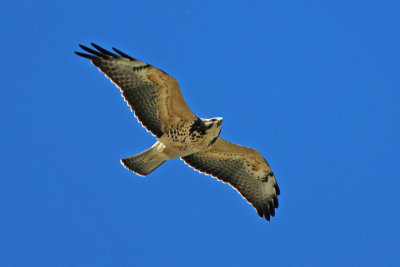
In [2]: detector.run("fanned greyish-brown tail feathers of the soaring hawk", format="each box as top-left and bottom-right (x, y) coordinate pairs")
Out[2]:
(121, 146), (165, 176)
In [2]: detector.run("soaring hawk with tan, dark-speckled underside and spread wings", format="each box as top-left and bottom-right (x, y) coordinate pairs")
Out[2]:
(75, 43), (280, 221)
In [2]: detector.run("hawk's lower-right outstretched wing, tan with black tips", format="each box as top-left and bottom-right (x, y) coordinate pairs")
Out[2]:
(182, 138), (280, 221)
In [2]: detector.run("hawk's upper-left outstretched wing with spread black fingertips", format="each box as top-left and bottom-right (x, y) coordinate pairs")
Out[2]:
(75, 43), (196, 137)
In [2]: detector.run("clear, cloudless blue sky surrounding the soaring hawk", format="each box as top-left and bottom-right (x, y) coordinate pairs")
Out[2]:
(0, 0), (400, 266)
